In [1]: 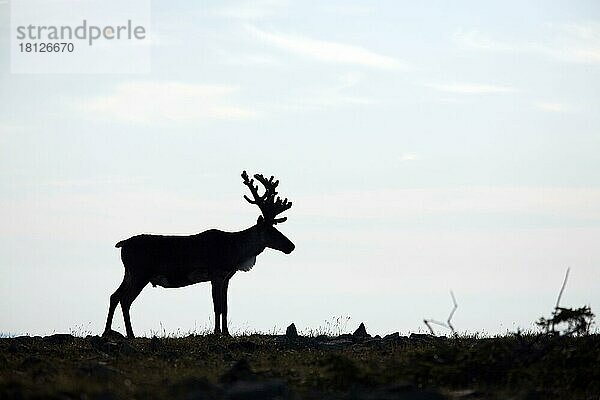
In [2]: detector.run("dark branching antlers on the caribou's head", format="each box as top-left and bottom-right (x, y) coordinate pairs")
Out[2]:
(242, 171), (292, 225)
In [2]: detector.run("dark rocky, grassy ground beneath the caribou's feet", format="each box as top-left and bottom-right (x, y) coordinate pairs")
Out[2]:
(0, 326), (600, 400)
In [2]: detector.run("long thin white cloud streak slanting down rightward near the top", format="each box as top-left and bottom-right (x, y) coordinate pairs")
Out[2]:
(247, 26), (402, 69)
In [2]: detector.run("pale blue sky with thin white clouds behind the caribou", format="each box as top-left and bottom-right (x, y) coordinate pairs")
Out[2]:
(0, 0), (600, 335)
